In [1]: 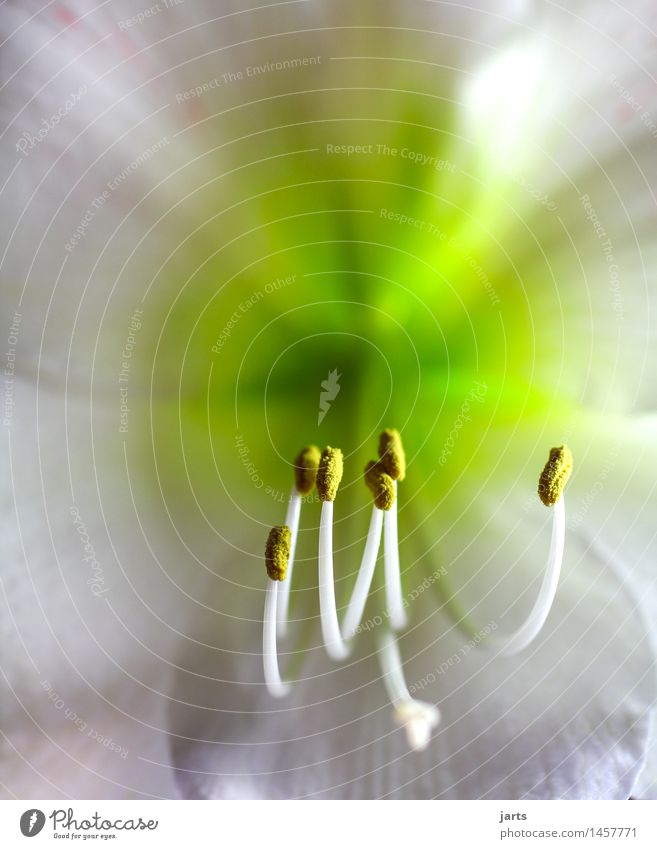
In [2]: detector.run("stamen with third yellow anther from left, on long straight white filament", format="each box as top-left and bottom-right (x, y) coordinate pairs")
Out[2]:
(317, 447), (349, 660)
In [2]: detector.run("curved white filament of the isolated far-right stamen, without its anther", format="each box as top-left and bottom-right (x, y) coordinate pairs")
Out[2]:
(489, 495), (566, 656)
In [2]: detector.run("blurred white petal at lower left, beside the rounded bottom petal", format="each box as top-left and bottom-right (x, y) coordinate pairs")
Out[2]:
(0, 379), (241, 798)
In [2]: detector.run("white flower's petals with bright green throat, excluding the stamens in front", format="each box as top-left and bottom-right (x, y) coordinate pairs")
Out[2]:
(0, 0), (657, 798)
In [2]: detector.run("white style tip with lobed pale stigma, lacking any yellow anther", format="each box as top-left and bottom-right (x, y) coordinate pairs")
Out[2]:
(379, 630), (440, 752)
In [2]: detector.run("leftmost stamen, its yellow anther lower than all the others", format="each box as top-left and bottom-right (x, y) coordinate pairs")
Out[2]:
(262, 525), (290, 698)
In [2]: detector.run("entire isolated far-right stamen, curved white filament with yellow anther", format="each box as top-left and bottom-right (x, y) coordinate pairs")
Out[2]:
(489, 445), (573, 657)
